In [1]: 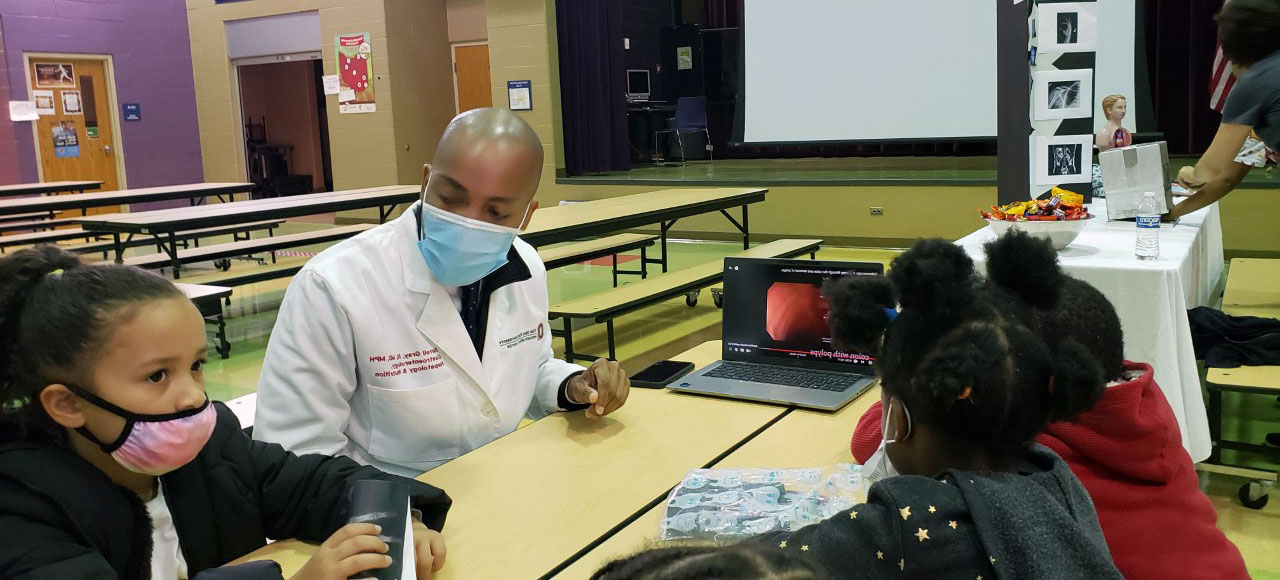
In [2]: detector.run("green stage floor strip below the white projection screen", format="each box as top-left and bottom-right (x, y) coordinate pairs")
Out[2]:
(557, 156), (1280, 188)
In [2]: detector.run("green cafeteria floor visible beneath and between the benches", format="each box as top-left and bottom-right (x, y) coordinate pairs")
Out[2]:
(183, 223), (1280, 580)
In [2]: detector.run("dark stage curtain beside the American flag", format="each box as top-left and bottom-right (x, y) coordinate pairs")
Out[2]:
(1142, 0), (1222, 155)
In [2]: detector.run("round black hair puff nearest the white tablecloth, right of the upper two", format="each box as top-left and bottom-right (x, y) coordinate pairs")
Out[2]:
(983, 229), (1064, 309)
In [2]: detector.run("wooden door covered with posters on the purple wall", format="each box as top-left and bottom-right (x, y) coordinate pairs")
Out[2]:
(29, 58), (120, 215)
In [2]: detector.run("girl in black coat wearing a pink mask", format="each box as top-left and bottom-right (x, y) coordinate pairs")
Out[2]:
(0, 246), (449, 579)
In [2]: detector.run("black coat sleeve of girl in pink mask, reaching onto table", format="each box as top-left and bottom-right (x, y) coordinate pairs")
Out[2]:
(225, 407), (452, 542)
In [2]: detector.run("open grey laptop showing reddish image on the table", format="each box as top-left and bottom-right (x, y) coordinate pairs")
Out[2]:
(667, 257), (884, 411)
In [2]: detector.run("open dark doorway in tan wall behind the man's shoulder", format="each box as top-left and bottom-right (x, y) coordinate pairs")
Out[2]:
(237, 55), (333, 197)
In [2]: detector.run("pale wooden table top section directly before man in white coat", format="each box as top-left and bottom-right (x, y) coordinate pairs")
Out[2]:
(230, 341), (788, 579)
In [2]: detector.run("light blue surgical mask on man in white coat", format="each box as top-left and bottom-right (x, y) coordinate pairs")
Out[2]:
(417, 202), (529, 286)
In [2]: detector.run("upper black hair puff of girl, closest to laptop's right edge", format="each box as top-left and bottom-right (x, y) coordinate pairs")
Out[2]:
(888, 238), (974, 318)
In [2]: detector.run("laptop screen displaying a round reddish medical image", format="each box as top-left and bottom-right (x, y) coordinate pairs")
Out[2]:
(723, 257), (884, 371)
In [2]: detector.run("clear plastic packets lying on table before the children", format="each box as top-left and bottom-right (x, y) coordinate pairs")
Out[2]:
(658, 463), (870, 542)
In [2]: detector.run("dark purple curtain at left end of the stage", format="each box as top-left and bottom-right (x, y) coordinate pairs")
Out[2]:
(556, 0), (631, 175)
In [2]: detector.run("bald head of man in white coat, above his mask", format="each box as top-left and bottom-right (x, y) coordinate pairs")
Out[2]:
(424, 108), (543, 227)
